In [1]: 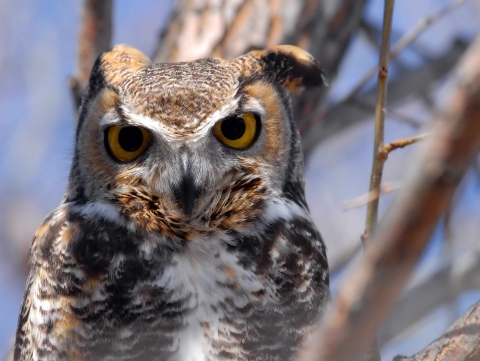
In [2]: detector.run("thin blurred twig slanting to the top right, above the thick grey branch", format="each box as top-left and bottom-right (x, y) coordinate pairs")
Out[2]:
(327, 0), (469, 112)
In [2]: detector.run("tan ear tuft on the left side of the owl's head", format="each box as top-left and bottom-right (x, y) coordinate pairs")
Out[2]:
(90, 44), (150, 86)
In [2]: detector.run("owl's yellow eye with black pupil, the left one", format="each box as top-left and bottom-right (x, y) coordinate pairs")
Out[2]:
(106, 125), (150, 162)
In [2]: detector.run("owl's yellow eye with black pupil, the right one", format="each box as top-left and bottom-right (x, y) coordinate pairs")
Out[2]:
(213, 113), (257, 149)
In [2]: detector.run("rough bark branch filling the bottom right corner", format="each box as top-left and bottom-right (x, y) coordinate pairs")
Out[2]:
(393, 302), (480, 361)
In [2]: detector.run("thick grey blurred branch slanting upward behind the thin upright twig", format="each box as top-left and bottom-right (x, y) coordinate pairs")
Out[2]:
(300, 41), (467, 158)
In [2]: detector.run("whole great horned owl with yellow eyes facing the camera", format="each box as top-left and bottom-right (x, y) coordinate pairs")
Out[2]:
(15, 46), (329, 361)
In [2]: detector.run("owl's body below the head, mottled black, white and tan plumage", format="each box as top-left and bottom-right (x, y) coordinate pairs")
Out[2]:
(15, 197), (328, 361)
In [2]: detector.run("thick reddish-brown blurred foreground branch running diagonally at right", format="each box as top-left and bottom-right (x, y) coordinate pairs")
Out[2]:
(299, 32), (480, 361)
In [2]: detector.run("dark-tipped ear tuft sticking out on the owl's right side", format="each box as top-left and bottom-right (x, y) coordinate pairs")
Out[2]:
(247, 45), (327, 92)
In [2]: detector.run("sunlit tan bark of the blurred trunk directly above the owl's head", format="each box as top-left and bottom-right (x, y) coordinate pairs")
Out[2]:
(153, 0), (298, 62)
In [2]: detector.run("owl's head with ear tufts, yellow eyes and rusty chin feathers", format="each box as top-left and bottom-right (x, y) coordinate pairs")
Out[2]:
(66, 45), (324, 240)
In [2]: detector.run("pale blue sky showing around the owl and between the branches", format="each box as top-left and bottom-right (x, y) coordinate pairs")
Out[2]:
(0, 0), (480, 358)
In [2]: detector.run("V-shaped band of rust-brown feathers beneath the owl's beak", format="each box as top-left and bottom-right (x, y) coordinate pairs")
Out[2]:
(112, 168), (268, 241)
